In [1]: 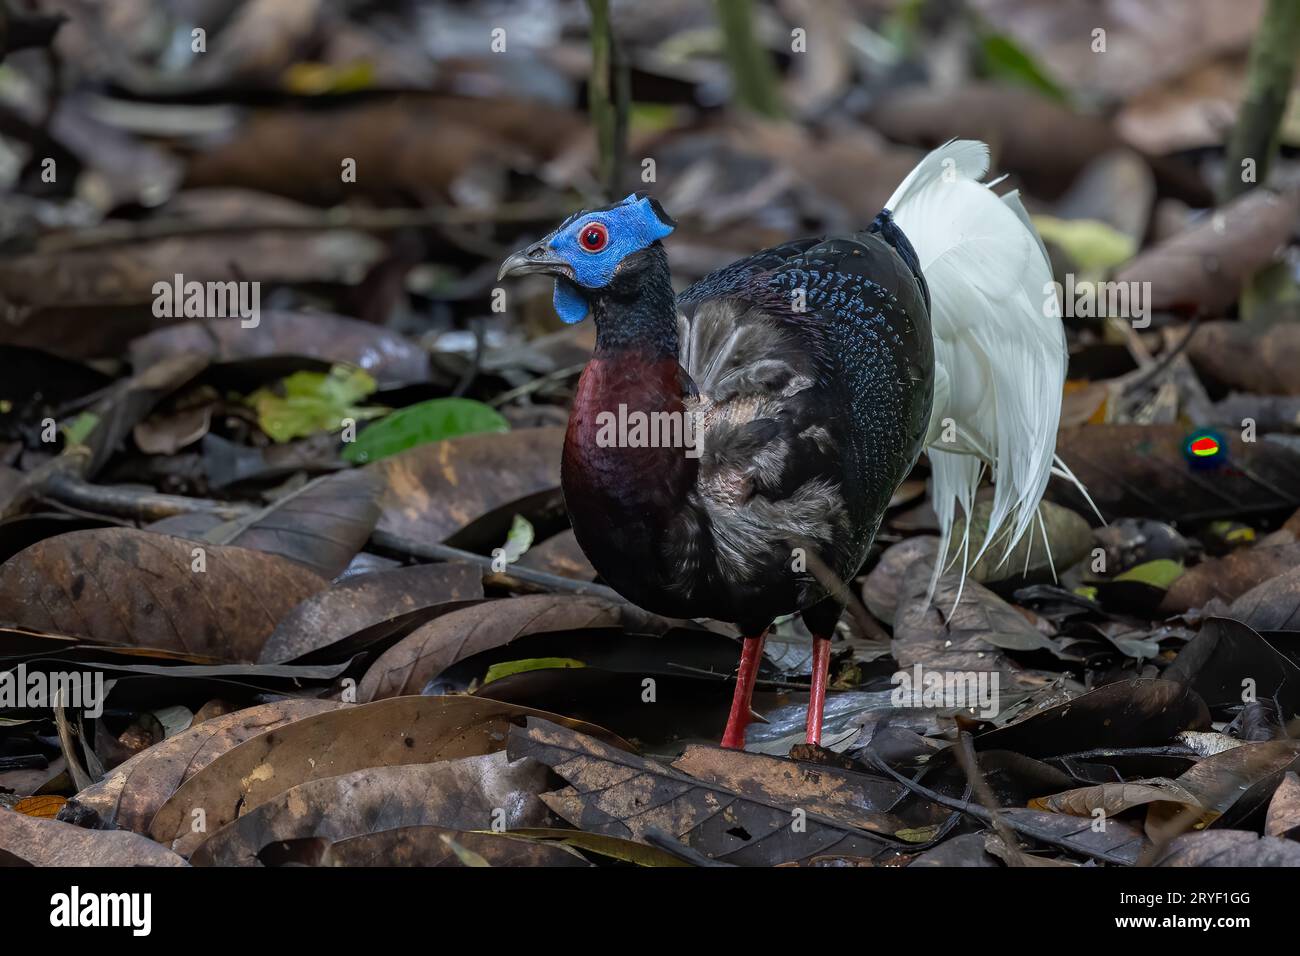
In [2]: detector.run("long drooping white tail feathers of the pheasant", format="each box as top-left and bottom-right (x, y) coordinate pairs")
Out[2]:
(887, 139), (1082, 600)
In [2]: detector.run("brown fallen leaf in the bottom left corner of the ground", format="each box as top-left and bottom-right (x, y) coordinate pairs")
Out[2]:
(0, 808), (186, 866)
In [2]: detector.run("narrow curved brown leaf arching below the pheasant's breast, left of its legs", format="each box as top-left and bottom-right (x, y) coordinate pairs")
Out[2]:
(358, 594), (670, 701)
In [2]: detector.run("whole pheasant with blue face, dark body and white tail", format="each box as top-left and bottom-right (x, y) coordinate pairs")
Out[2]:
(498, 140), (1082, 749)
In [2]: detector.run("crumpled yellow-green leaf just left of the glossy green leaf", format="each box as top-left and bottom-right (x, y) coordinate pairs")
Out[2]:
(244, 365), (387, 442)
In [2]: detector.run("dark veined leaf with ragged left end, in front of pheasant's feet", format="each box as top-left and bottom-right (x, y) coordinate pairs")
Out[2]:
(507, 719), (889, 865)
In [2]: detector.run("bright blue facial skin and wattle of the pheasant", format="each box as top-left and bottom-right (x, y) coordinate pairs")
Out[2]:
(546, 194), (672, 323)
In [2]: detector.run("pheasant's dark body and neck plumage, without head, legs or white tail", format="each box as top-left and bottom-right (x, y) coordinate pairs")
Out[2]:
(563, 213), (935, 633)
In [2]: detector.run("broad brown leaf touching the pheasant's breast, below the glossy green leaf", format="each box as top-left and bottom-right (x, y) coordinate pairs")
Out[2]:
(365, 428), (564, 541)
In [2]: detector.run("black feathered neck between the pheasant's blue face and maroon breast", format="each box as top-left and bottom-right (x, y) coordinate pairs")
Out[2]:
(590, 242), (677, 359)
